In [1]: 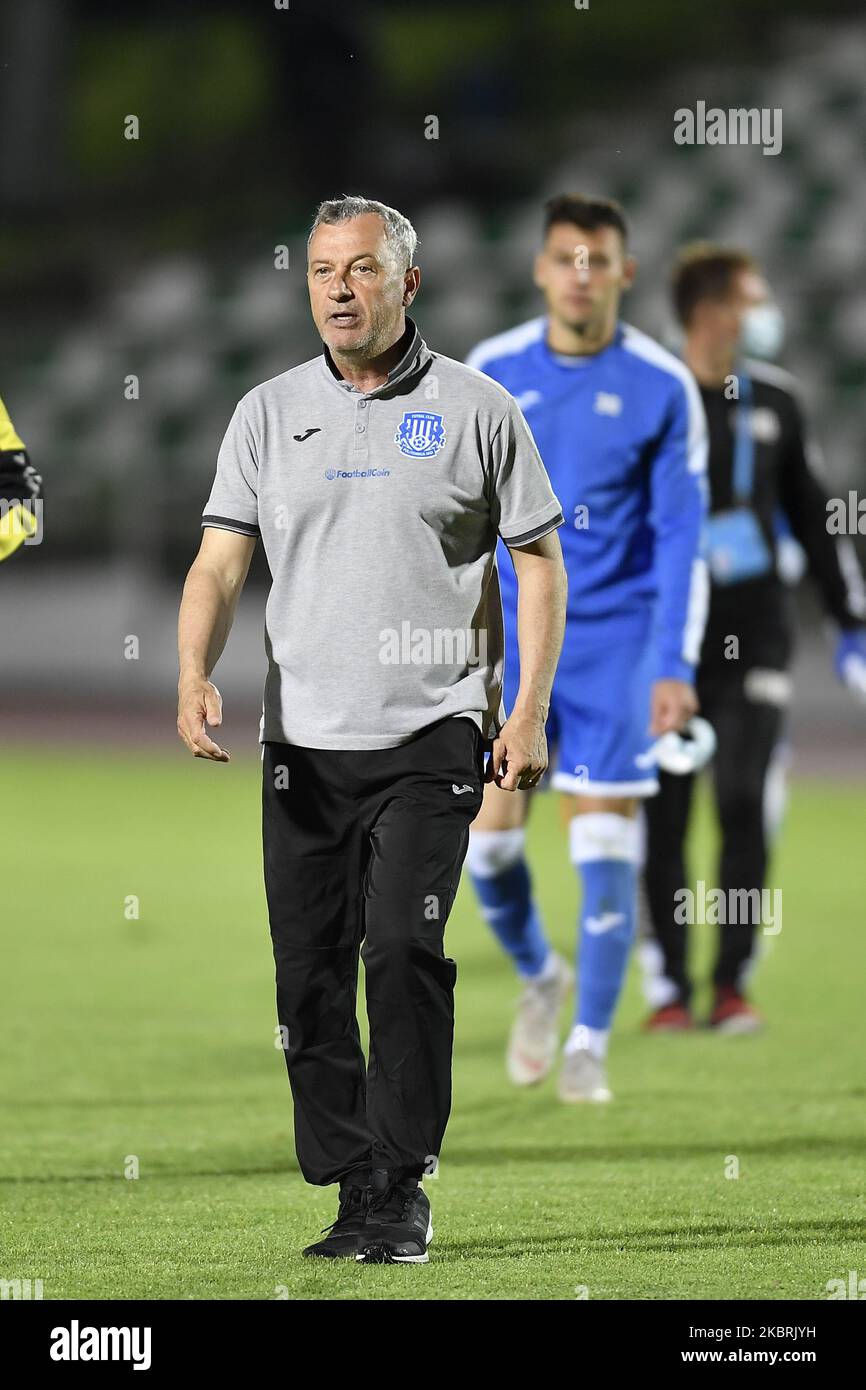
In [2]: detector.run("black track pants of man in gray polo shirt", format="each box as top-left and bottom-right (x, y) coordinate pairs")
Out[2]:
(263, 719), (484, 1183)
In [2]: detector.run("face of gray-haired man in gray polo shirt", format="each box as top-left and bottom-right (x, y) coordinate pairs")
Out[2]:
(307, 213), (417, 357)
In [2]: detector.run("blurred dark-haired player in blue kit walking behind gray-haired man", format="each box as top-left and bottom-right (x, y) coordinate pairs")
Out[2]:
(467, 195), (708, 1101)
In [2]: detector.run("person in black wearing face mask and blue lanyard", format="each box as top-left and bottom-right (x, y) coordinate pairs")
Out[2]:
(641, 243), (866, 1033)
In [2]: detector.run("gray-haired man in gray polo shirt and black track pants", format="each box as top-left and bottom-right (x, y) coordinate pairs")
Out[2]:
(178, 197), (564, 1264)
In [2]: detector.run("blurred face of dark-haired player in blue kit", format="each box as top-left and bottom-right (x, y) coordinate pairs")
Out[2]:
(535, 222), (635, 334)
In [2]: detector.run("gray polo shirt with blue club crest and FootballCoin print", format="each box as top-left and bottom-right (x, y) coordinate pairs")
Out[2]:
(202, 320), (563, 749)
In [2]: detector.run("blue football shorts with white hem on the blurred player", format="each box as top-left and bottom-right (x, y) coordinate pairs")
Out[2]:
(505, 614), (659, 796)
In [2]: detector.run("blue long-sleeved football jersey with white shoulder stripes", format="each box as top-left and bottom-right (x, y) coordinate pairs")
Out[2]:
(467, 316), (709, 680)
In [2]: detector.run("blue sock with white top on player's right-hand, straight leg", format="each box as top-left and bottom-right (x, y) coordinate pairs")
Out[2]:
(571, 812), (638, 1030)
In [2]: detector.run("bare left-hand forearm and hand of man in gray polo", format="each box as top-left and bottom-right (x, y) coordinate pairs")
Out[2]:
(178, 527), (256, 763)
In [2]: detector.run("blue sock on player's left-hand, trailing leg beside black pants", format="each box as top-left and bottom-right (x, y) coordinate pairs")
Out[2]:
(466, 830), (550, 979)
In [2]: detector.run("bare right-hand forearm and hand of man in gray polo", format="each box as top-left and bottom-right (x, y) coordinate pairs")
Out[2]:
(488, 531), (567, 791)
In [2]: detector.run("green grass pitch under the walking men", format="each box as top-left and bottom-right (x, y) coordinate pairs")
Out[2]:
(0, 748), (866, 1300)
